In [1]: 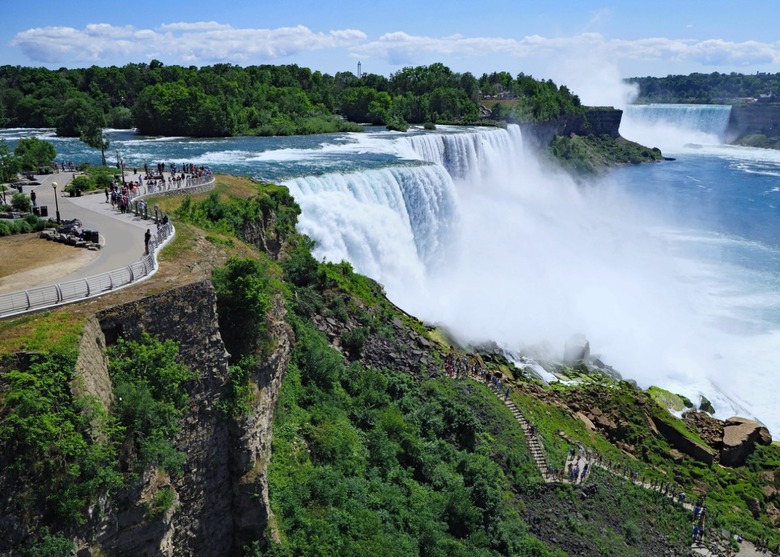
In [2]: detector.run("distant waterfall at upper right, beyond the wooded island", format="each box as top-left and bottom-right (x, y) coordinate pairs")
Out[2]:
(620, 104), (731, 150)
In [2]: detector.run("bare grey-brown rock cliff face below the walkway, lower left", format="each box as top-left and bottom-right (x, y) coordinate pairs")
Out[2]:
(0, 281), (292, 557)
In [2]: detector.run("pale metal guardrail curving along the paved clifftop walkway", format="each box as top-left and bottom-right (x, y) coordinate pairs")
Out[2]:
(0, 172), (215, 319)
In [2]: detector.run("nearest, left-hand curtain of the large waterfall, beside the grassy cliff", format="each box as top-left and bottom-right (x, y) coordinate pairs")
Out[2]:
(285, 164), (460, 284)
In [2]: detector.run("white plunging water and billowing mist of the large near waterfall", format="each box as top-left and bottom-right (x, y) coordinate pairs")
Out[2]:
(288, 120), (780, 434)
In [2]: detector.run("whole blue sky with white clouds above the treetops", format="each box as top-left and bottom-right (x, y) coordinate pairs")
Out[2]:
(0, 0), (780, 104)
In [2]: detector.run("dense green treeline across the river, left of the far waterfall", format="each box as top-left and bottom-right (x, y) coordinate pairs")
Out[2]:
(0, 60), (581, 137)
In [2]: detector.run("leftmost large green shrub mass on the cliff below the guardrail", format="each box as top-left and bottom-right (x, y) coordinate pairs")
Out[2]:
(0, 348), (122, 523)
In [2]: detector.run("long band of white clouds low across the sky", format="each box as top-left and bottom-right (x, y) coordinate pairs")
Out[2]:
(11, 21), (780, 77)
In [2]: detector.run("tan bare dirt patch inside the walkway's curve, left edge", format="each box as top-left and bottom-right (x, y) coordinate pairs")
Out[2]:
(0, 233), (99, 294)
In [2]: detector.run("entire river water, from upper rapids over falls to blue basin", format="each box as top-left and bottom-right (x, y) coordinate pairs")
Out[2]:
(6, 121), (780, 431)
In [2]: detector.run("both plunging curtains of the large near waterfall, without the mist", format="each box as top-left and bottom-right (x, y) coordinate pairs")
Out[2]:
(285, 126), (522, 290)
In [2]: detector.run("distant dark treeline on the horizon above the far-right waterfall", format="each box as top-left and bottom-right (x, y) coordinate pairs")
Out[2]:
(626, 72), (780, 104)
